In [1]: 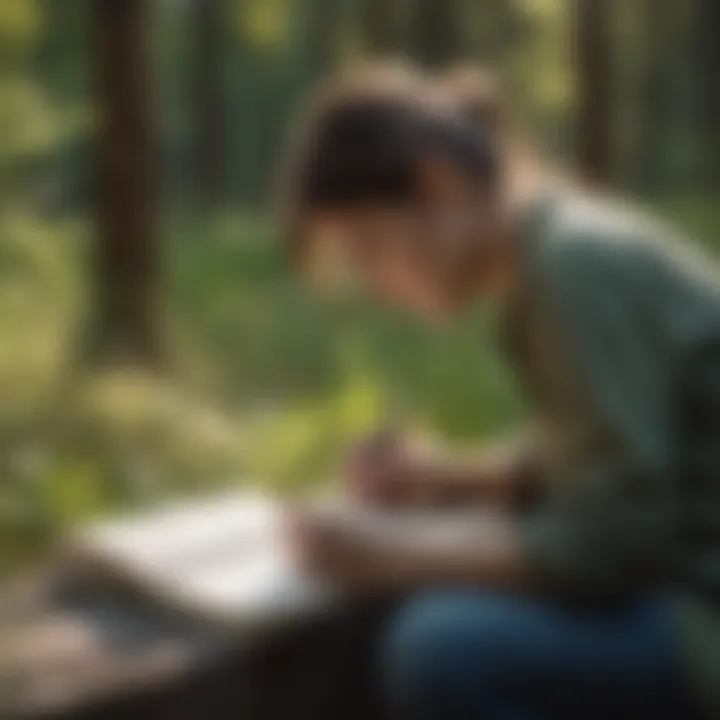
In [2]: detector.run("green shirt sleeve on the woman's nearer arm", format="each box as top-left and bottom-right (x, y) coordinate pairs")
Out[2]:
(521, 228), (678, 599)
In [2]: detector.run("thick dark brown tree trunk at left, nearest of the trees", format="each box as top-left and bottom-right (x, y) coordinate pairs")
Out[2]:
(91, 0), (160, 364)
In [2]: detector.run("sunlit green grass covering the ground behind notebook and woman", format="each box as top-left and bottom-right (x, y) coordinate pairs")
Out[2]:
(0, 201), (720, 567)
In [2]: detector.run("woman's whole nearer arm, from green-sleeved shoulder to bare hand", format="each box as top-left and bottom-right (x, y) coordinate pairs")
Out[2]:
(300, 221), (680, 601)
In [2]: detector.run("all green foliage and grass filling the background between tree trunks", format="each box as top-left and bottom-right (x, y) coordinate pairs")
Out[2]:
(0, 0), (720, 567)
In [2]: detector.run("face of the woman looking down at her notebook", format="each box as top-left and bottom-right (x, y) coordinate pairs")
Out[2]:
(304, 163), (506, 320)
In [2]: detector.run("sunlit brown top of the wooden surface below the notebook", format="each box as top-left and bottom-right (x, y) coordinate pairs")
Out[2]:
(0, 578), (227, 717)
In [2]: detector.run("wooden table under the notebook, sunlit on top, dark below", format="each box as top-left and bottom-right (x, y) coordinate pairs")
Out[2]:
(0, 577), (389, 720)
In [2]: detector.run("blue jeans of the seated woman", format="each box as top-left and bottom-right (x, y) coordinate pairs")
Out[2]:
(381, 590), (698, 720)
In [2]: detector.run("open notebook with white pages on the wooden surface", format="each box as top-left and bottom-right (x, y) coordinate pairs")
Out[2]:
(65, 492), (333, 629)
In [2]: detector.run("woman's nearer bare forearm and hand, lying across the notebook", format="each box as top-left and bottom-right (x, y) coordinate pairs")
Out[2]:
(293, 504), (532, 593)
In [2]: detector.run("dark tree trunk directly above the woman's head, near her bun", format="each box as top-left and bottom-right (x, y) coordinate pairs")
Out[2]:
(412, 0), (462, 68)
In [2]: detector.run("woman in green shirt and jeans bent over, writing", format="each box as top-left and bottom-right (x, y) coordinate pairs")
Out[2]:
(283, 66), (720, 720)
